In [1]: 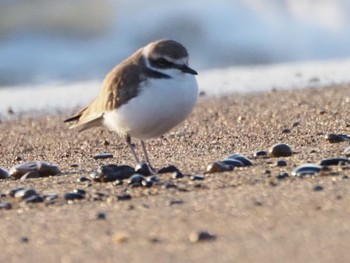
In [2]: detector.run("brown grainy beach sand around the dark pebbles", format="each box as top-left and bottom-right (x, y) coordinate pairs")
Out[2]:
(0, 86), (350, 262)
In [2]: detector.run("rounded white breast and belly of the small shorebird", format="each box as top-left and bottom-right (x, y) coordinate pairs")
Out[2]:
(104, 74), (198, 140)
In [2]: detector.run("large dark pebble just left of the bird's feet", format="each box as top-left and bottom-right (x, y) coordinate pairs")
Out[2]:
(90, 164), (135, 182)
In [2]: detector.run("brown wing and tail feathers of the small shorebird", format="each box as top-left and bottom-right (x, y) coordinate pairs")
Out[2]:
(64, 50), (145, 131)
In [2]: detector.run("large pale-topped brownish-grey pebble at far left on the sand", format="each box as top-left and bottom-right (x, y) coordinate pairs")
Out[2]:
(10, 161), (61, 179)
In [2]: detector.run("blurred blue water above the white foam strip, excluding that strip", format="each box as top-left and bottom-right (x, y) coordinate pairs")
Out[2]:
(0, 0), (350, 87)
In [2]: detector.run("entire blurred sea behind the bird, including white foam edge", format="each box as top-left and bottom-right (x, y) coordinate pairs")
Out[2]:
(0, 0), (350, 112)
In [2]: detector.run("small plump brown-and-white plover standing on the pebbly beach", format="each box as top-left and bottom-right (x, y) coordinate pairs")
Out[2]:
(65, 40), (198, 167)
